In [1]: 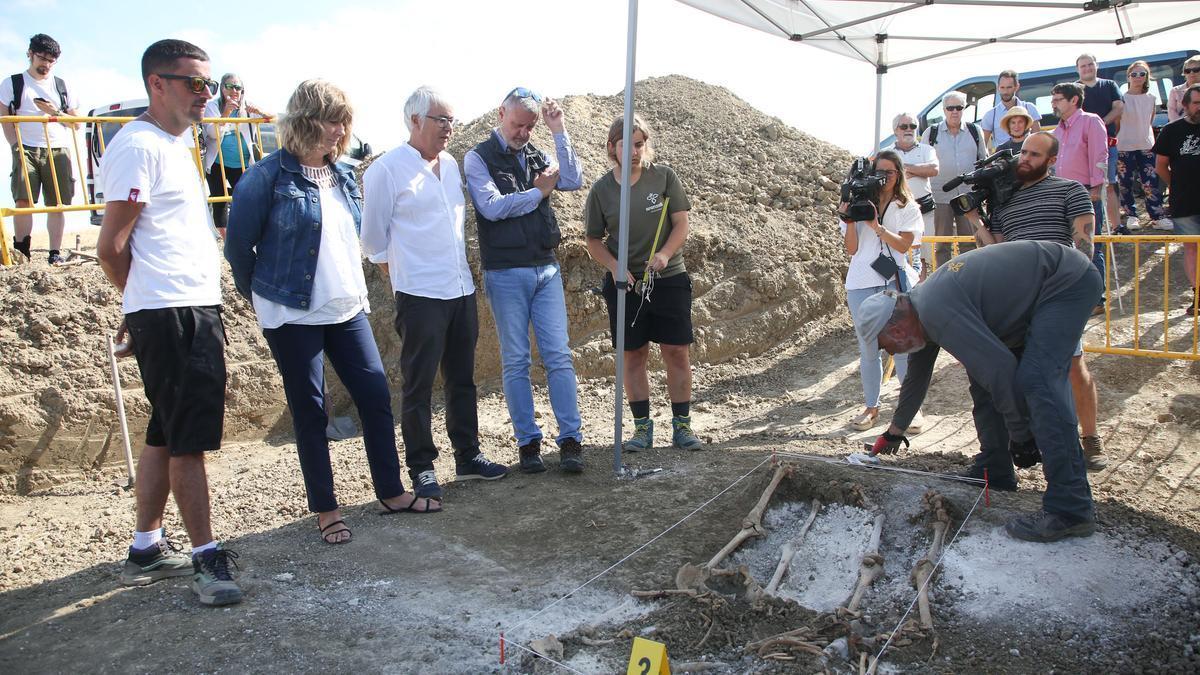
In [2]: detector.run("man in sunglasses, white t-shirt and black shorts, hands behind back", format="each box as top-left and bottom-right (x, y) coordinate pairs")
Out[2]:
(96, 40), (241, 605)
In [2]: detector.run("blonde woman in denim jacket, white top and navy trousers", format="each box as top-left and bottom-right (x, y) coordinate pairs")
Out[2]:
(224, 80), (442, 544)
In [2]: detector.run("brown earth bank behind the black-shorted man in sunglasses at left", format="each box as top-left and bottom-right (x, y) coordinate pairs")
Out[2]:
(0, 263), (286, 494)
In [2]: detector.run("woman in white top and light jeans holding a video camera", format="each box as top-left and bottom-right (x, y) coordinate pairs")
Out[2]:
(838, 150), (924, 434)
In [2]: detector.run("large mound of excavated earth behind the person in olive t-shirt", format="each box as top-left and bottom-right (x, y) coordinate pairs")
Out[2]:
(368, 76), (851, 383)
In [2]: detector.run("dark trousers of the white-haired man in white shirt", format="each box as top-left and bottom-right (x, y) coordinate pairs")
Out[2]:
(396, 293), (479, 479)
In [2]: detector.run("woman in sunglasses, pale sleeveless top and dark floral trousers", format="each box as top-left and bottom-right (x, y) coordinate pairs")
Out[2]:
(1117, 61), (1175, 229)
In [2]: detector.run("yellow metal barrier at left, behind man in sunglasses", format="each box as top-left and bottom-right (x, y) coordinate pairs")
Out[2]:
(0, 115), (274, 265)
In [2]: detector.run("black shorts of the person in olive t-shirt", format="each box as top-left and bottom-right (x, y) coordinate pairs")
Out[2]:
(604, 273), (695, 352)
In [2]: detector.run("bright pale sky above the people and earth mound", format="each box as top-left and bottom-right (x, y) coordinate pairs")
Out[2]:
(0, 0), (1196, 153)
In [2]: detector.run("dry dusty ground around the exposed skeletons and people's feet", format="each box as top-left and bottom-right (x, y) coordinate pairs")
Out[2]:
(0, 239), (1200, 673)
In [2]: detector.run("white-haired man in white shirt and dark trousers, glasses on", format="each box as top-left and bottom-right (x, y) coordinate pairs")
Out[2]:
(361, 86), (508, 498)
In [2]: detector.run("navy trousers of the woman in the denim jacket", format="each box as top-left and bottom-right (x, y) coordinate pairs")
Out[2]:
(263, 312), (404, 513)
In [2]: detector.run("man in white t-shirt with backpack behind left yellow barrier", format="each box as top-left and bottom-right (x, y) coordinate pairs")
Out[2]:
(0, 32), (78, 264)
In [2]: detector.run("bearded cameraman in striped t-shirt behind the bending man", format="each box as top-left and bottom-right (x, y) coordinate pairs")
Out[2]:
(966, 131), (1106, 471)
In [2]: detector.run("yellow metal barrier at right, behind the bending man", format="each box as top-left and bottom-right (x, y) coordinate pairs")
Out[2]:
(922, 234), (1200, 360)
